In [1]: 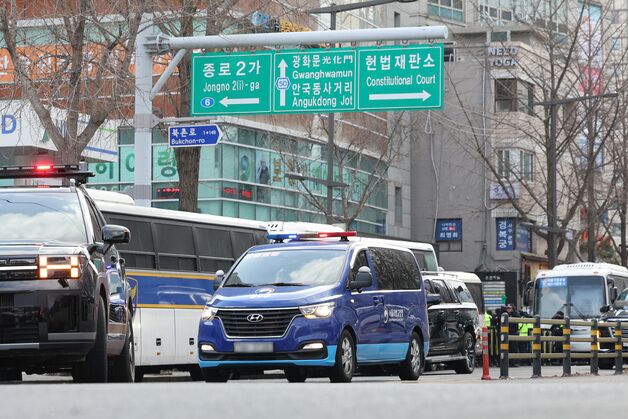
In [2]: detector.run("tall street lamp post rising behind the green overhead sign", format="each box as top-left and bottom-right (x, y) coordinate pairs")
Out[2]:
(307, 0), (416, 224)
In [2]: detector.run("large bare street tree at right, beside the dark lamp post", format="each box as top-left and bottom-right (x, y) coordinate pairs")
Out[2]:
(435, 0), (620, 260)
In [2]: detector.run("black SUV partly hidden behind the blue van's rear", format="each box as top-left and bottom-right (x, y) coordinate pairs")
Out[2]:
(423, 274), (479, 374)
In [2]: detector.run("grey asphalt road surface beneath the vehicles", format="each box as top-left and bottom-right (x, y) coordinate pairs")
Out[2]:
(0, 367), (628, 419)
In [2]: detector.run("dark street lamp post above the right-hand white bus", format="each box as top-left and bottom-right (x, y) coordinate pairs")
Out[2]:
(532, 93), (617, 269)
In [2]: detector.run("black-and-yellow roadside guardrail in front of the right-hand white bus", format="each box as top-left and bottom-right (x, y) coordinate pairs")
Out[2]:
(499, 313), (628, 379)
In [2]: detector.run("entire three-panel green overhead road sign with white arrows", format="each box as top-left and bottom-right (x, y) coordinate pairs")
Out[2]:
(191, 44), (444, 116)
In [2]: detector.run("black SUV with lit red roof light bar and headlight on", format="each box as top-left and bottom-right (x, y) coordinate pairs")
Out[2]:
(0, 165), (135, 382)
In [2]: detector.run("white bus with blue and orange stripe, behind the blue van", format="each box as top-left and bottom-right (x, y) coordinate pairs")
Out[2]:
(92, 193), (267, 381)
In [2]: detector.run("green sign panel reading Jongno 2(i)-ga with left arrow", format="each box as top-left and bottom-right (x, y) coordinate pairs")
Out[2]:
(190, 52), (273, 115)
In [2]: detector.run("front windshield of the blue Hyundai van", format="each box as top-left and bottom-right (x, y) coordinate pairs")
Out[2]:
(224, 249), (346, 287)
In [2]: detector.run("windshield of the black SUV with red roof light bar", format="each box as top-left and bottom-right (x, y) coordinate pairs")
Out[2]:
(0, 192), (87, 243)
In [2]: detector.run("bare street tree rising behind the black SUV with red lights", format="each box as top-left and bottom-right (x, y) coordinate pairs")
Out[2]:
(0, 0), (144, 164)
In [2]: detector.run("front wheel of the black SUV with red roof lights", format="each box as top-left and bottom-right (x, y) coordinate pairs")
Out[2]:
(72, 297), (107, 383)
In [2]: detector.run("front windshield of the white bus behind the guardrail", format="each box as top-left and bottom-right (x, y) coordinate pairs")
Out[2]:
(536, 276), (606, 319)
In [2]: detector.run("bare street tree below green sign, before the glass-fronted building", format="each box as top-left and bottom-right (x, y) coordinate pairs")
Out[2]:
(271, 111), (416, 230)
